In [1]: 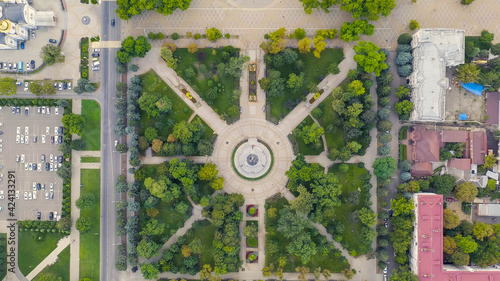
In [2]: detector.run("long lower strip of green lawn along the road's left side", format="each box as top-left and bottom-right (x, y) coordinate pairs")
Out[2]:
(80, 169), (101, 280)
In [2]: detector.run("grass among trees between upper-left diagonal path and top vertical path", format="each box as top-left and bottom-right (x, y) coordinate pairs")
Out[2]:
(174, 48), (239, 119)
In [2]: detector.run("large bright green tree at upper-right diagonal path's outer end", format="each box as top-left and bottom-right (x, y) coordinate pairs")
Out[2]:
(354, 40), (388, 76)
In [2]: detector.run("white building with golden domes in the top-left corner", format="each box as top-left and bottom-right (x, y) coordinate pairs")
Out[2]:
(0, 0), (56, 50)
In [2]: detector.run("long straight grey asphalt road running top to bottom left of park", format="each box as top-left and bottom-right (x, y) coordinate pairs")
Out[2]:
(100, 1), (121, 280)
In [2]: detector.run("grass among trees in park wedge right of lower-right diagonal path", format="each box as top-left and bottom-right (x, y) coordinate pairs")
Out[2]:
(325, 164), (368, 255)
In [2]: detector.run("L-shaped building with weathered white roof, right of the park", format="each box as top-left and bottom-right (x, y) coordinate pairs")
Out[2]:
(408, 28), (465, 122)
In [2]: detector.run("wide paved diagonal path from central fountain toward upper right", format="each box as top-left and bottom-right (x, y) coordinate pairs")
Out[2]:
(278, 49), (356, 134)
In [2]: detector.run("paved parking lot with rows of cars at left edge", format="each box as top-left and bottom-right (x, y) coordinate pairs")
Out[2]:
(0, 107), (63, 220)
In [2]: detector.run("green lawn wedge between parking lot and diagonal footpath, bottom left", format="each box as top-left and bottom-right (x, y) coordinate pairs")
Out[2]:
(18, 231), (63, 276)
